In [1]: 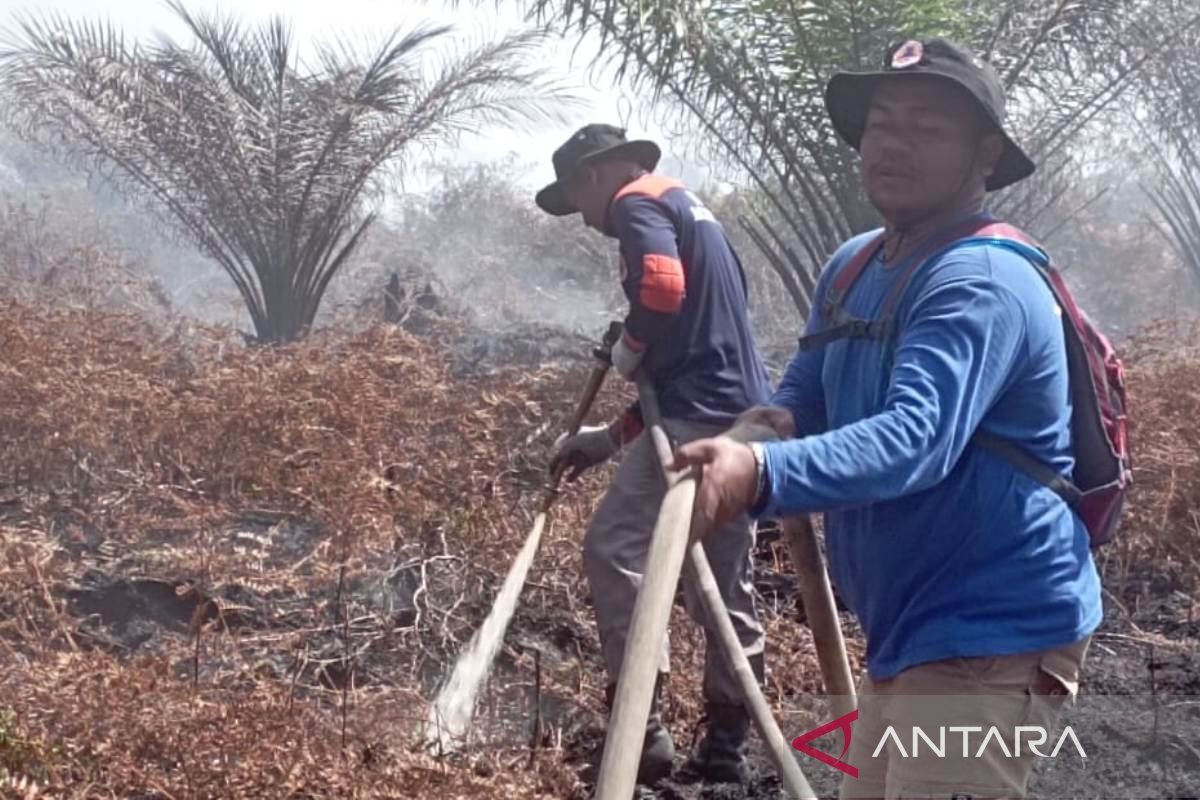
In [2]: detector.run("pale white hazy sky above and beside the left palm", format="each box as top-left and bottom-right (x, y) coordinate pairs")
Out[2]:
(0, 0), (686, 186)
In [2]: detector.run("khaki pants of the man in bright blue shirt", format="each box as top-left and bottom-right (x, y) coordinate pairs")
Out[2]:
(841, 639), (1090, 800)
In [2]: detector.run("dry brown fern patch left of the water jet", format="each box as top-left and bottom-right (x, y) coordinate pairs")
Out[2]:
(0, 298), (609, 796)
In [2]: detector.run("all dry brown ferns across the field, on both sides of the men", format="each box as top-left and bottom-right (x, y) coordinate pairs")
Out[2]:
(0, 303), (1200, 799)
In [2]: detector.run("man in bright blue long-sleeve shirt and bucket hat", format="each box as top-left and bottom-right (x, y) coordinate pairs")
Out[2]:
(679, 40), (1102, 798)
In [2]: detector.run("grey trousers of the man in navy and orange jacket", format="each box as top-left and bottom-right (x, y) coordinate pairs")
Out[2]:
(583, 420), (764, 704)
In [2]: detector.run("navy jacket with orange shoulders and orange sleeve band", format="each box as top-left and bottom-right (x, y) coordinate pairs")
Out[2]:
(608, 175), (770, 423)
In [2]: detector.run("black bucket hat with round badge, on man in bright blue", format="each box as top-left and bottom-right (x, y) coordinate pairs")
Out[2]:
(824, 38), (1037, 192)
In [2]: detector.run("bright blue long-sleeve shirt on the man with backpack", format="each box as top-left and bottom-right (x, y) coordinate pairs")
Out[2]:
(762, 231), (1102, 680)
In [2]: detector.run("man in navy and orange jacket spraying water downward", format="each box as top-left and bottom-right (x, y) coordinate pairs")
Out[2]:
(536, 125), (770, 783)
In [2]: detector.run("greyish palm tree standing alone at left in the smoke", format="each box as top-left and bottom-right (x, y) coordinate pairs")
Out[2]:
(0, 0), (571, 343)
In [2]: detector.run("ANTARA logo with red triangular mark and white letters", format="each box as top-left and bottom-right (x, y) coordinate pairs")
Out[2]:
(792, 709), (1087, 777)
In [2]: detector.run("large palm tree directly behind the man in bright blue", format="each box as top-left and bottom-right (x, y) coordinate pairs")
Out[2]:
(523, 0), (1198, 315)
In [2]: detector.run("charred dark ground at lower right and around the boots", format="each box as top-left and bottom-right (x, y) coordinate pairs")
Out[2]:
(644, 591), (1200, 800)
